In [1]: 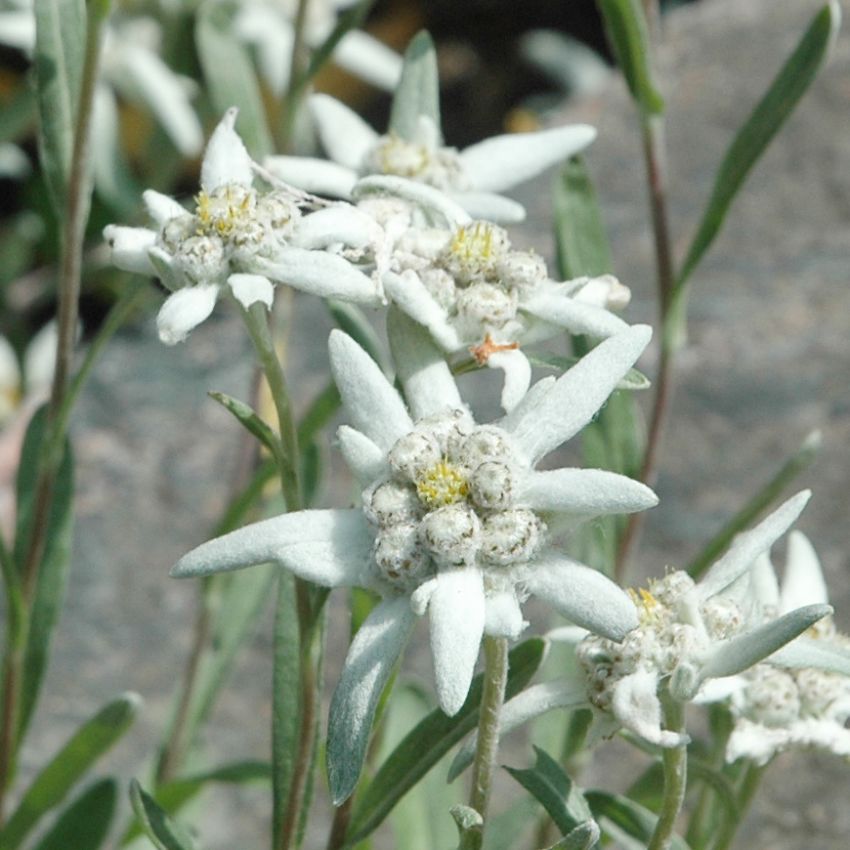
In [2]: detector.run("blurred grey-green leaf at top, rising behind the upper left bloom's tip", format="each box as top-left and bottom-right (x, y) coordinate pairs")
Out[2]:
(195, 3), (273, 160)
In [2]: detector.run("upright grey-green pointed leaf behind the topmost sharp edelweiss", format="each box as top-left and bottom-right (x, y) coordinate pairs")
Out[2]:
(390, 30), (440, 142)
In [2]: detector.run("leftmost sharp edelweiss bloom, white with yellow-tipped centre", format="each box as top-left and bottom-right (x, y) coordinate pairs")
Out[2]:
(104, 109), (381, 345)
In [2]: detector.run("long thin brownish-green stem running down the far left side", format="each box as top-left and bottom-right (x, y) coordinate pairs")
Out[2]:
(0, 2), (106, 823)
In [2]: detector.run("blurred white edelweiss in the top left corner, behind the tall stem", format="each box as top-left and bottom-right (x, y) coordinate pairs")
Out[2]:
(0, 0), (204, 159)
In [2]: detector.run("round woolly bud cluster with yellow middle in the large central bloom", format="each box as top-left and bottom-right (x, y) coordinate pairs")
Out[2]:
(364, 410), (545, 591)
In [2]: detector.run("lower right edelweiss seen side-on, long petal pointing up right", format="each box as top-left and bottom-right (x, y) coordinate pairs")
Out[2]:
(460, 491), (832, 756)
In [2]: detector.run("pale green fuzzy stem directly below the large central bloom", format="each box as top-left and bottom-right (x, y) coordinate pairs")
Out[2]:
(462, 636), (508, 850)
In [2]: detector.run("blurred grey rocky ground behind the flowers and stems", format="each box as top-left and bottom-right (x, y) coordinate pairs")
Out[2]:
(14, 0), (850, 850)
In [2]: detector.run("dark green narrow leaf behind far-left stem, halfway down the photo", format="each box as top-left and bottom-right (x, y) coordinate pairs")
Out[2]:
(14, 407), (74, 737)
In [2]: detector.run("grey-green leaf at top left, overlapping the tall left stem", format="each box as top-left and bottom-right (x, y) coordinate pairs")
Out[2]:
(33, 0), (86, 211)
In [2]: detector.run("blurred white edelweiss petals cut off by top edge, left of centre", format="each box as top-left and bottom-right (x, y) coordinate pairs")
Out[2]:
(233, 0), (401, 96)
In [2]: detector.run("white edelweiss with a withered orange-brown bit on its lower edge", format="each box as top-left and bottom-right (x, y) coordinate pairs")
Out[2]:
(372, 209), (631, 411)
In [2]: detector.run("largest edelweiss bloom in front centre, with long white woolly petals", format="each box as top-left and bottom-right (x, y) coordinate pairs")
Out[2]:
(173, 311), (657, 801)
